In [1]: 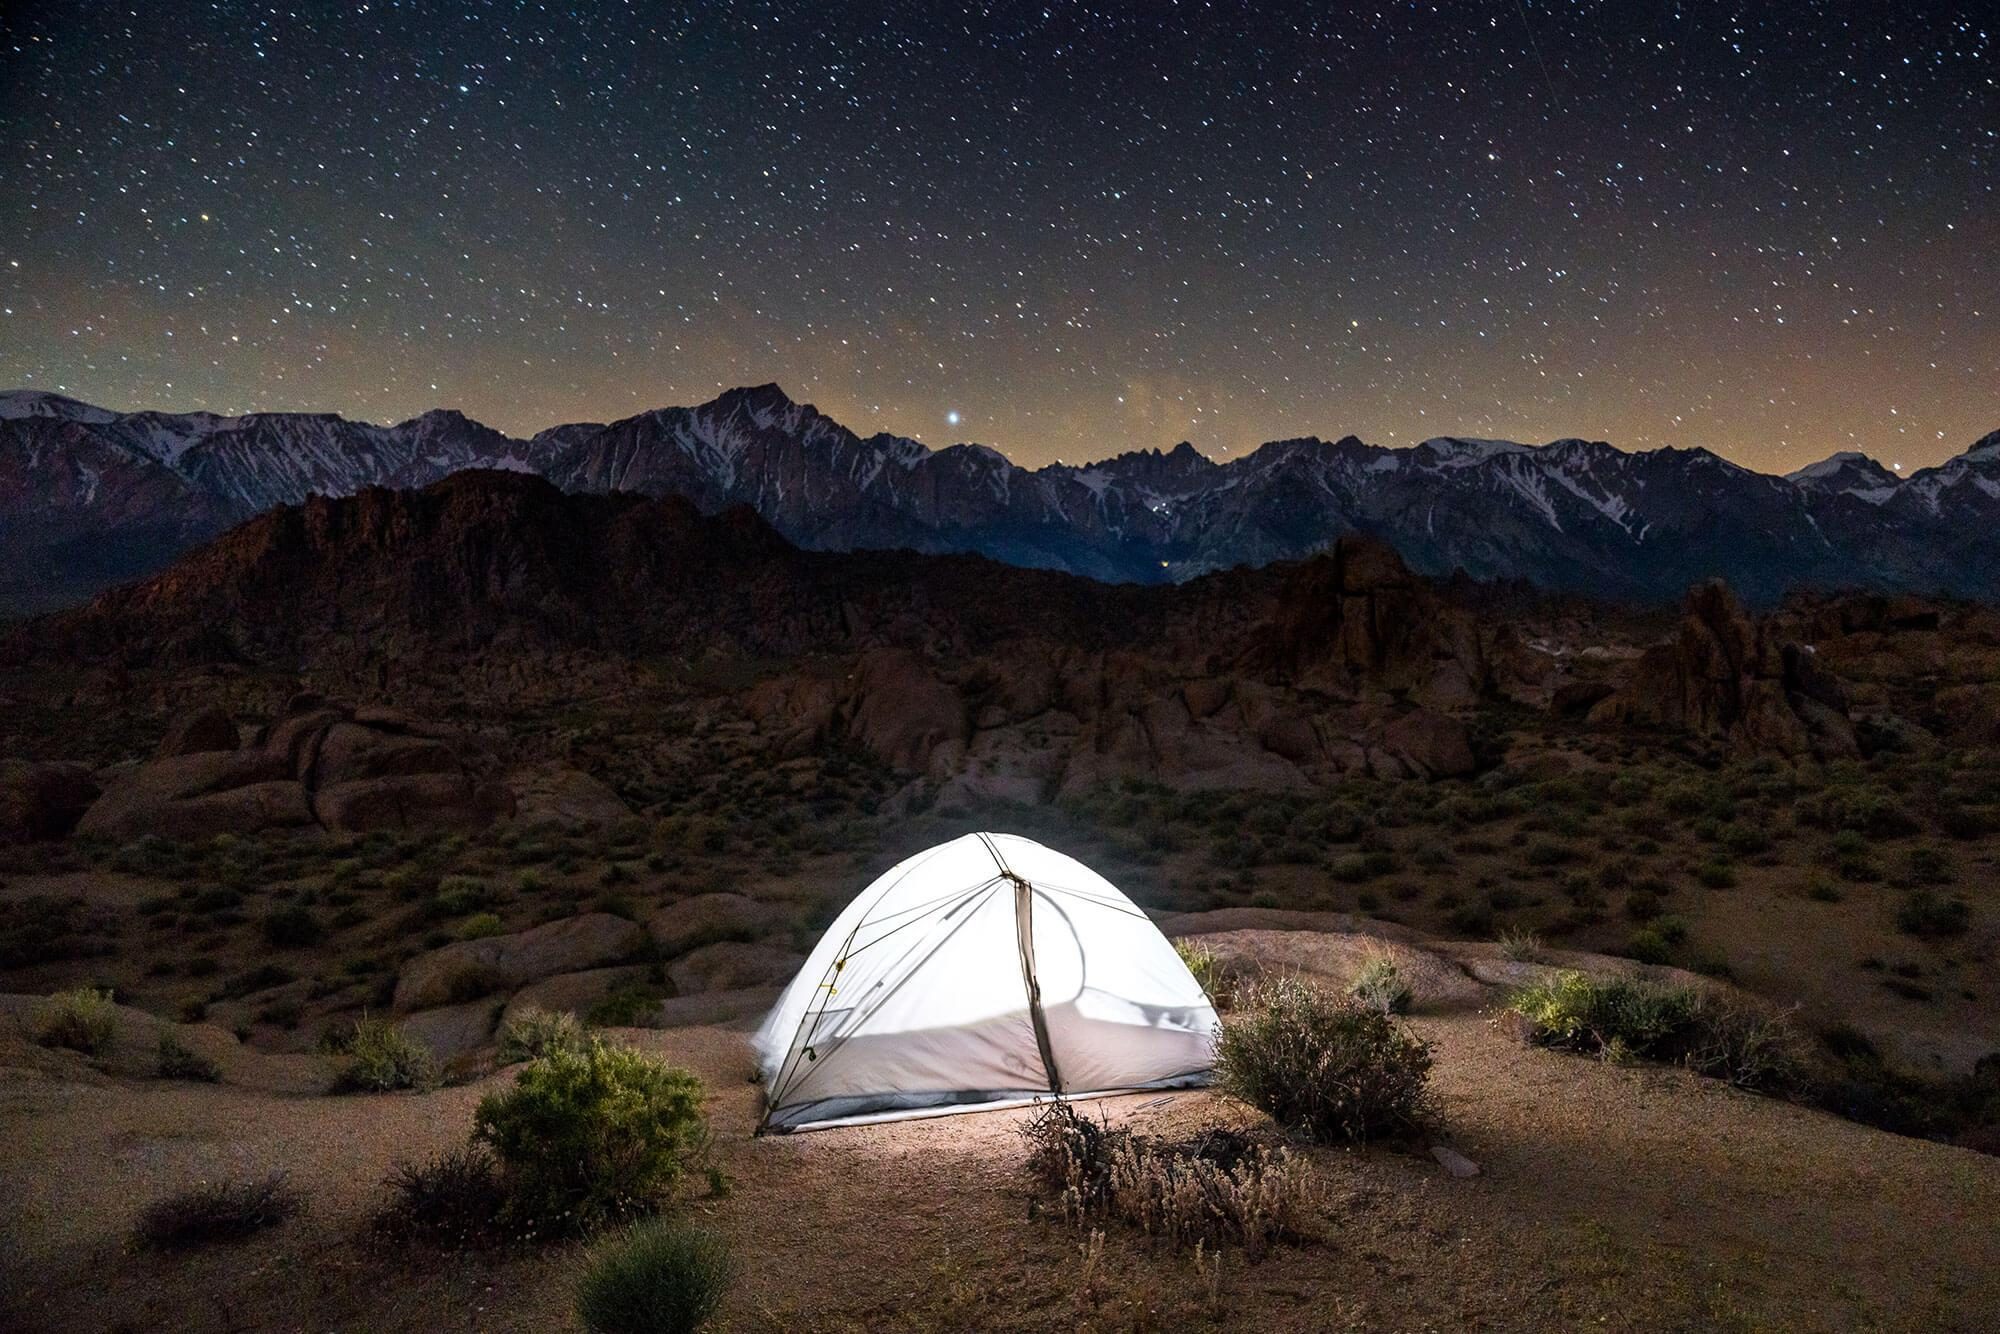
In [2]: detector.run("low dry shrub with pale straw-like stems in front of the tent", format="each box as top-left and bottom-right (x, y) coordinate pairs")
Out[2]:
(1022, 1098), (1318, 1258)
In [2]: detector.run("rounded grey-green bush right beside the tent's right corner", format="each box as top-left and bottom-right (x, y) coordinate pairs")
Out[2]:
(1216, 978), (1430, 1144)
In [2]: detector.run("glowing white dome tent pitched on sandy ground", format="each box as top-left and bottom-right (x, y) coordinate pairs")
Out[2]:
(756, 834), (1216, 1132)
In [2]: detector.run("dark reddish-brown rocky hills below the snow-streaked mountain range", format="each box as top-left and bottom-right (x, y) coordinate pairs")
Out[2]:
(0, 472), (2000, 820)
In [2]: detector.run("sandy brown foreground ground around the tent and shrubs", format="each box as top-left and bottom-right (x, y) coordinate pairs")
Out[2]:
(0, 1014), (2000, 1334)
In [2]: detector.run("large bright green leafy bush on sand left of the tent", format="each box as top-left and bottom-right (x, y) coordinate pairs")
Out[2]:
(472, 1038), (708, 1232)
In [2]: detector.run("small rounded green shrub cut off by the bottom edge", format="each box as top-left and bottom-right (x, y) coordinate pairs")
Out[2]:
(576, 1218), (736, 1334)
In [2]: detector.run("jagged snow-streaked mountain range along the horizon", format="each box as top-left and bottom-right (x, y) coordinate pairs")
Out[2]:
(0, 384), (2000, 614)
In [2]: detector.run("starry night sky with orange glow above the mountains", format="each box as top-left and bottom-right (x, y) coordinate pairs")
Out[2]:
(0, 0), (2000, 470)
